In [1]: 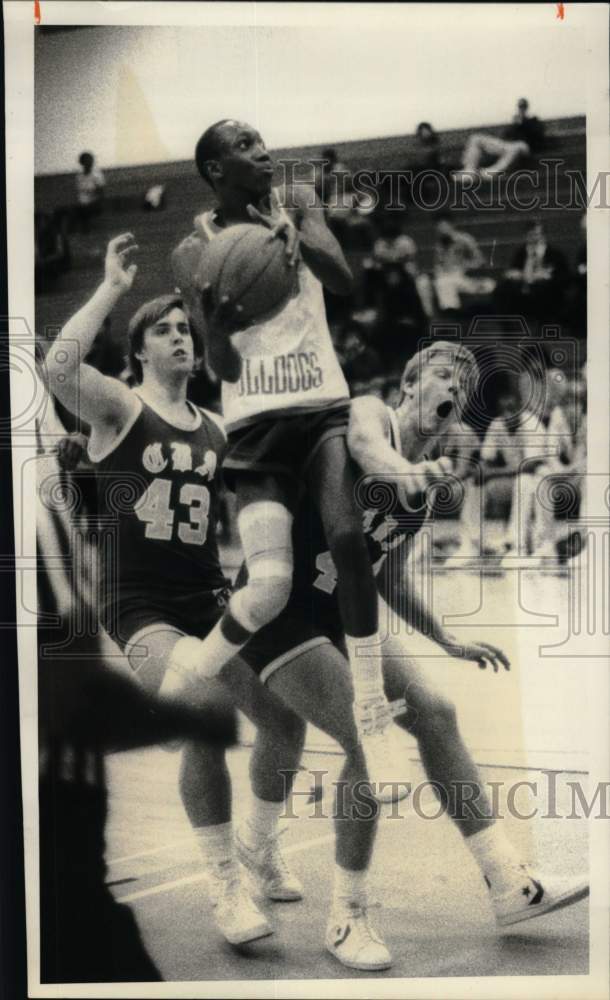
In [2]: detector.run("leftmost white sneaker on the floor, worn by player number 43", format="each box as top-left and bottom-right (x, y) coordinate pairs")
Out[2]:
(209, 861), (273, 944)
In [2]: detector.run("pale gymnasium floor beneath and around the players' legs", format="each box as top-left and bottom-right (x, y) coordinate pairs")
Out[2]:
(106, 570), (588, 982)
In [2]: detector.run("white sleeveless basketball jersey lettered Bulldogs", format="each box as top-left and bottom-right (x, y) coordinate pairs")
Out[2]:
(195, 190), (349, 430)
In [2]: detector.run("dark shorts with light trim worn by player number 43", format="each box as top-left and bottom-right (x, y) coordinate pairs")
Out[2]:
(104, 585), (231, 652)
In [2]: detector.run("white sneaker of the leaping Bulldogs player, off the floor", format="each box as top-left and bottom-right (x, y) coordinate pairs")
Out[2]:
(354, 694), (411, 802)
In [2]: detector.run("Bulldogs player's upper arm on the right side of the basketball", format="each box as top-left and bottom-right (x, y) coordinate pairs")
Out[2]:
(282, 184), (354, 295)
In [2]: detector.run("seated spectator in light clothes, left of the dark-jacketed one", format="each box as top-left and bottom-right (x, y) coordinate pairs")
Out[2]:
(434, 212), (495, 312)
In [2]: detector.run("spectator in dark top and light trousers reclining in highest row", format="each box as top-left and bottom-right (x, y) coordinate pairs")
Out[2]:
(454, 97), (544, 180)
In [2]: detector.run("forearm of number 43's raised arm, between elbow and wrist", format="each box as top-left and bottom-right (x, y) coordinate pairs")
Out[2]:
(46, 281), (122, 388)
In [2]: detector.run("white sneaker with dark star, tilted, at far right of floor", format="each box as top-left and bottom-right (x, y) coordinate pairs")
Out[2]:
(491, 865), (589, 927)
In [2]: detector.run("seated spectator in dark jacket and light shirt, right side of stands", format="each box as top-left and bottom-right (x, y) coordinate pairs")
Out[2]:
(496, 221), (569, 323)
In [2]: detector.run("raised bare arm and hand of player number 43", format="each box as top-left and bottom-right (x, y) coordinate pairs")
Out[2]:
(46, 233), (137, 427)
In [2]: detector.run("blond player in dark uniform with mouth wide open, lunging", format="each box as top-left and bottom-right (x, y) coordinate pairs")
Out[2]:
(232, 342), (588, 969)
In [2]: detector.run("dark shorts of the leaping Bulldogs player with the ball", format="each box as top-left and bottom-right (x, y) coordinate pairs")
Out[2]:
(223, 400), (349, 489)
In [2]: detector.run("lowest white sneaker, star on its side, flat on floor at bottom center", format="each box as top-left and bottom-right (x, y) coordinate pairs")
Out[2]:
(326, 903), (392, 972)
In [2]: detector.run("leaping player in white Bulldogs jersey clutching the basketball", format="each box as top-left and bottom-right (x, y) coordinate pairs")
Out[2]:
(173, 119), (402, 785)
